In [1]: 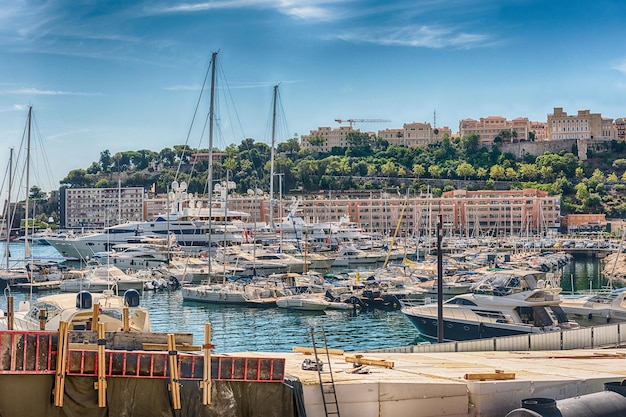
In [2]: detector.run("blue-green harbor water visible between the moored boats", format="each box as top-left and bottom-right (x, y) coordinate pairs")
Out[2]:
(0, 243), (606, 353)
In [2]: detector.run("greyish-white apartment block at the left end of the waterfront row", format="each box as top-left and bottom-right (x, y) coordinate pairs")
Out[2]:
(59, 187), (146, 229)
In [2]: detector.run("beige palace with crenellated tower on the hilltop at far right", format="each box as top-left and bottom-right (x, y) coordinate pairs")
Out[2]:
(547, 107), (617, 140)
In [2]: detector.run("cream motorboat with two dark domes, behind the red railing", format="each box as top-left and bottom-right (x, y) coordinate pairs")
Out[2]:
(0, 290), (151, 332)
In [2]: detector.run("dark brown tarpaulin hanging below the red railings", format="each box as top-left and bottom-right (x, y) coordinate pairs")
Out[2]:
(0, 375), (302, 417)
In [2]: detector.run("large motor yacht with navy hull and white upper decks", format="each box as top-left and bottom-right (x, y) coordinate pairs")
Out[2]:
(402, 269), (578, 341)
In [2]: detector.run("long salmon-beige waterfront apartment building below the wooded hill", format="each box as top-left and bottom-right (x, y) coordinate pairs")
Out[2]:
(223, 189), (561, 236)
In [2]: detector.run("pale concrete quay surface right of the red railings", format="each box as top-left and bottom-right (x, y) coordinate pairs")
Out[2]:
(243, 349), (626, 417)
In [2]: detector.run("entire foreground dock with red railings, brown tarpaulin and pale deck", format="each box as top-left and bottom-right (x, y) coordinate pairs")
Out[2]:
(0, 324), (626, 417)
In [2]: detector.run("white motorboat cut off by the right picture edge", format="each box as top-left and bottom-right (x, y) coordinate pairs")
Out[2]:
(561, 288), (626, 324)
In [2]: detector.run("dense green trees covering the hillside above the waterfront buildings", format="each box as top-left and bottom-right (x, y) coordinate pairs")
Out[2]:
(61, 131), (626, 217)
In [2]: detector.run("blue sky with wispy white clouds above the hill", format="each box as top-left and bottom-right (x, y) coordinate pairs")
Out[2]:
(0, 0), (626, 191)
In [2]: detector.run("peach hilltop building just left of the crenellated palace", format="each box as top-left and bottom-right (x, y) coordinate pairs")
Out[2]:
(459, 116), (531, 145)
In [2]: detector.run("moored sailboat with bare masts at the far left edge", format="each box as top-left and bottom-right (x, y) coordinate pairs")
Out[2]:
(0, 106), (61, 288)
